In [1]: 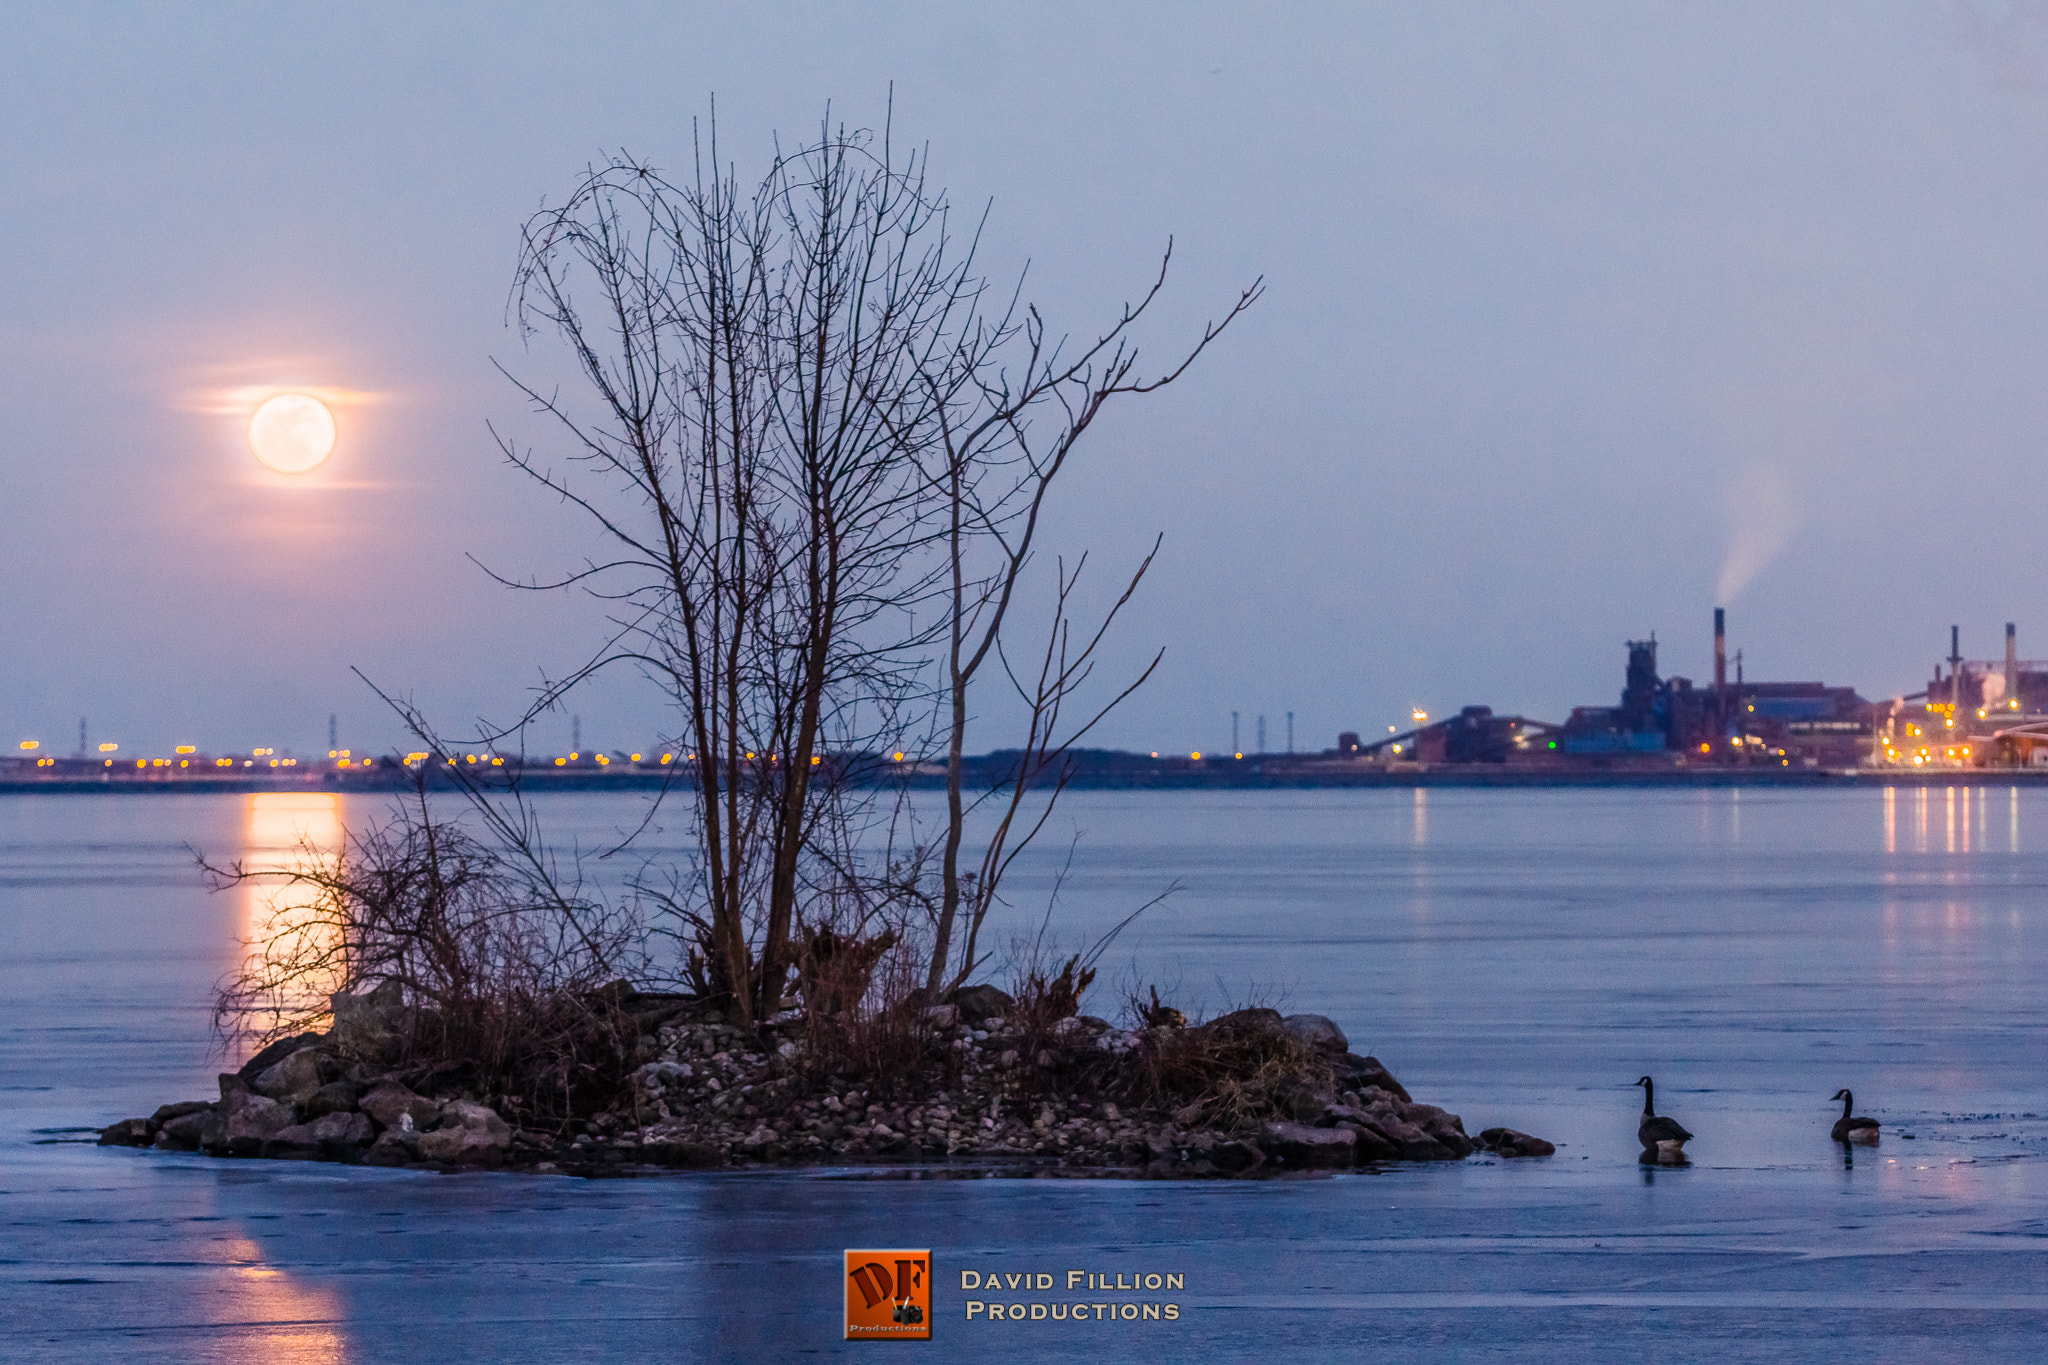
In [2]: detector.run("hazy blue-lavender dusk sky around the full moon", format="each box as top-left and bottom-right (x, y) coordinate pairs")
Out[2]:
(0, 0), (2048, 753)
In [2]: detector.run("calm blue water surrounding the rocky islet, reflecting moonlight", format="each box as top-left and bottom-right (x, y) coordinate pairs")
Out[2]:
(0, 788), (2048, 1361)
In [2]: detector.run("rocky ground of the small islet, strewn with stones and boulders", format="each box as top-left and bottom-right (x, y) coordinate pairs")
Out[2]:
(100, 986), (1554, 1179)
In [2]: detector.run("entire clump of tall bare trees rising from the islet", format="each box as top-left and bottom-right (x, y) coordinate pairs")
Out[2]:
(500, 101), (1260, 1023)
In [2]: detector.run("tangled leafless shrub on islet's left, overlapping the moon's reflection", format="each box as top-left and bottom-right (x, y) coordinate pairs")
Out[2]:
(201, 794), (643, 1124)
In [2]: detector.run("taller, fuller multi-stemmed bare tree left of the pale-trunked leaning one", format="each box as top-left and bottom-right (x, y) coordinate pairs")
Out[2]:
(502, 109), (979, 1021)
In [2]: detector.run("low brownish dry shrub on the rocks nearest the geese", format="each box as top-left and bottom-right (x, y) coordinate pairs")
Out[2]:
(1124, 997), (1335, 1128)
